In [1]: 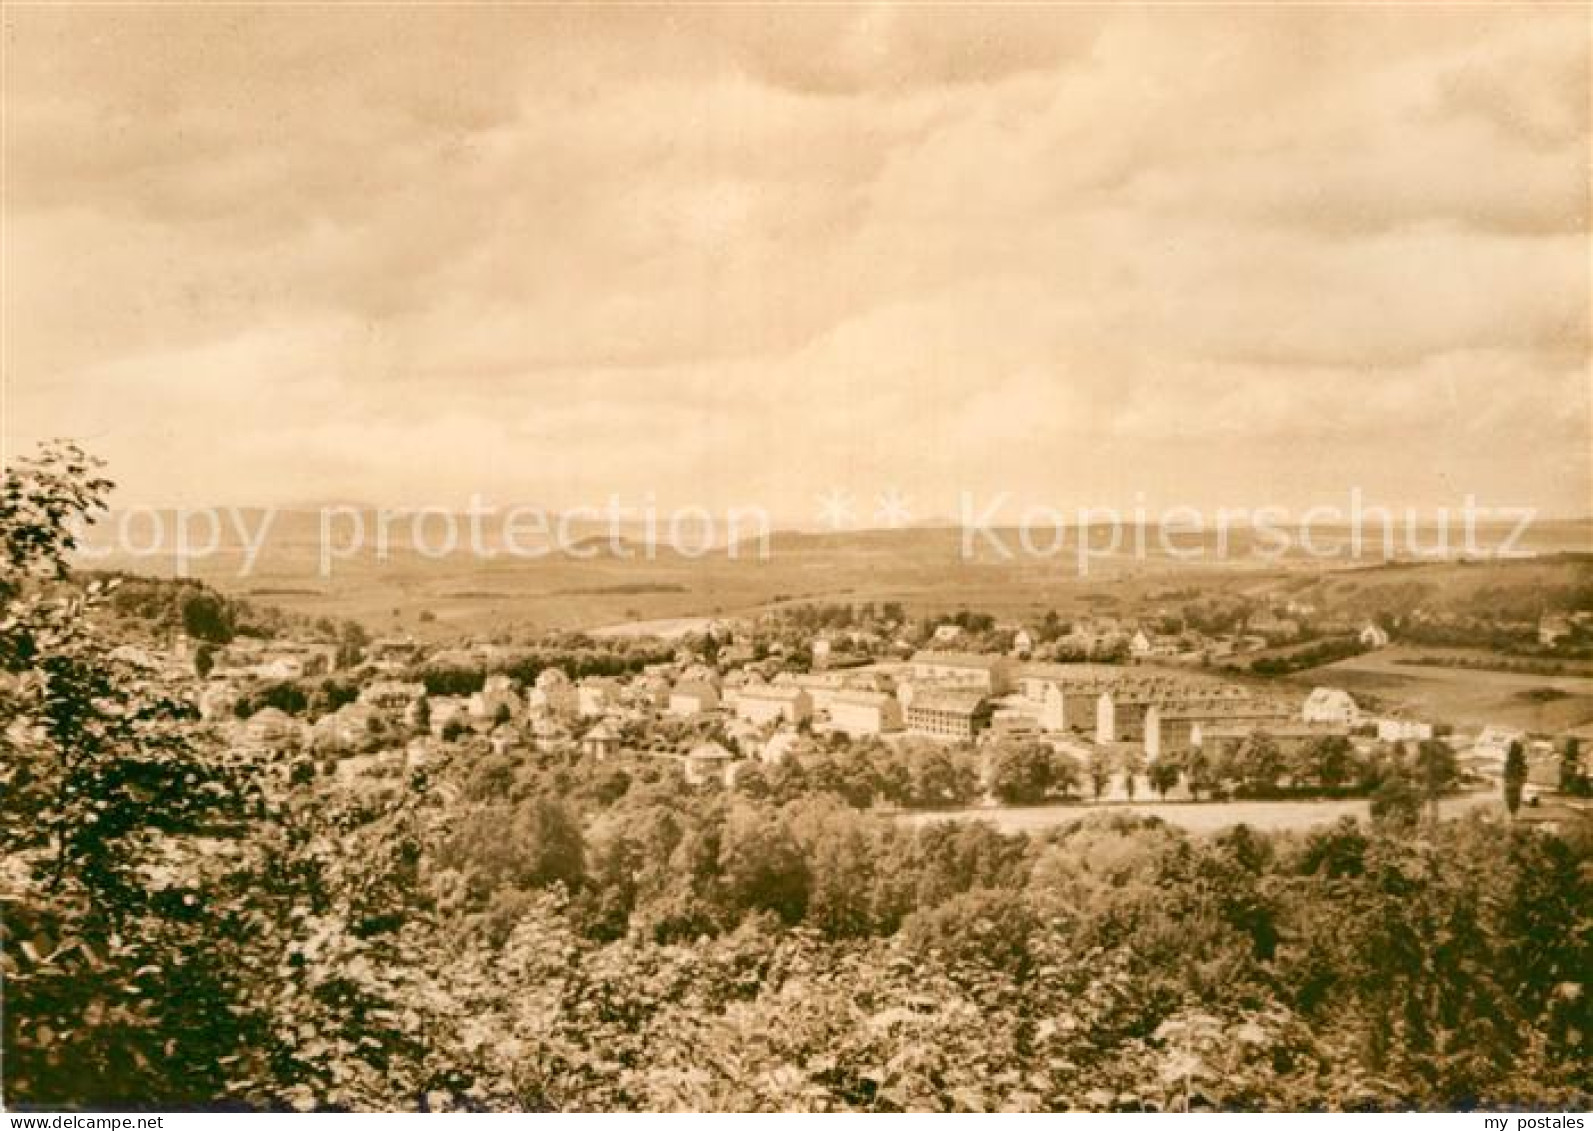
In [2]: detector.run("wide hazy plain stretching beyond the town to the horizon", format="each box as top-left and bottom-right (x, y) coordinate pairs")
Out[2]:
(80, 513), (1593, 640)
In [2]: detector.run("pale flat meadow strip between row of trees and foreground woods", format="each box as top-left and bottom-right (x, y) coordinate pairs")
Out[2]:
(902, 792), (1504, 836)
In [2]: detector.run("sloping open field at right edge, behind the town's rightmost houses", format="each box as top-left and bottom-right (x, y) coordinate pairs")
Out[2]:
(1290, 648), (1593, 733)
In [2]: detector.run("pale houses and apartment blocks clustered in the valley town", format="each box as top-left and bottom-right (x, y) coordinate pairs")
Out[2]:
(201, 611), (1580, 796)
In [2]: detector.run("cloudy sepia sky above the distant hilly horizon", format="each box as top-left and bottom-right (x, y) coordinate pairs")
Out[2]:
(3, 5), (1593, 519)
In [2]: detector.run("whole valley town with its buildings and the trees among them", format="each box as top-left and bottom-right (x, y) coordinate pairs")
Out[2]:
(105, 586), (1593, 822)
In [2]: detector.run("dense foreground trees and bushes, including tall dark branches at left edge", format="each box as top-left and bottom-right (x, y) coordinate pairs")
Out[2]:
(0, 448), (1593, 1110)
